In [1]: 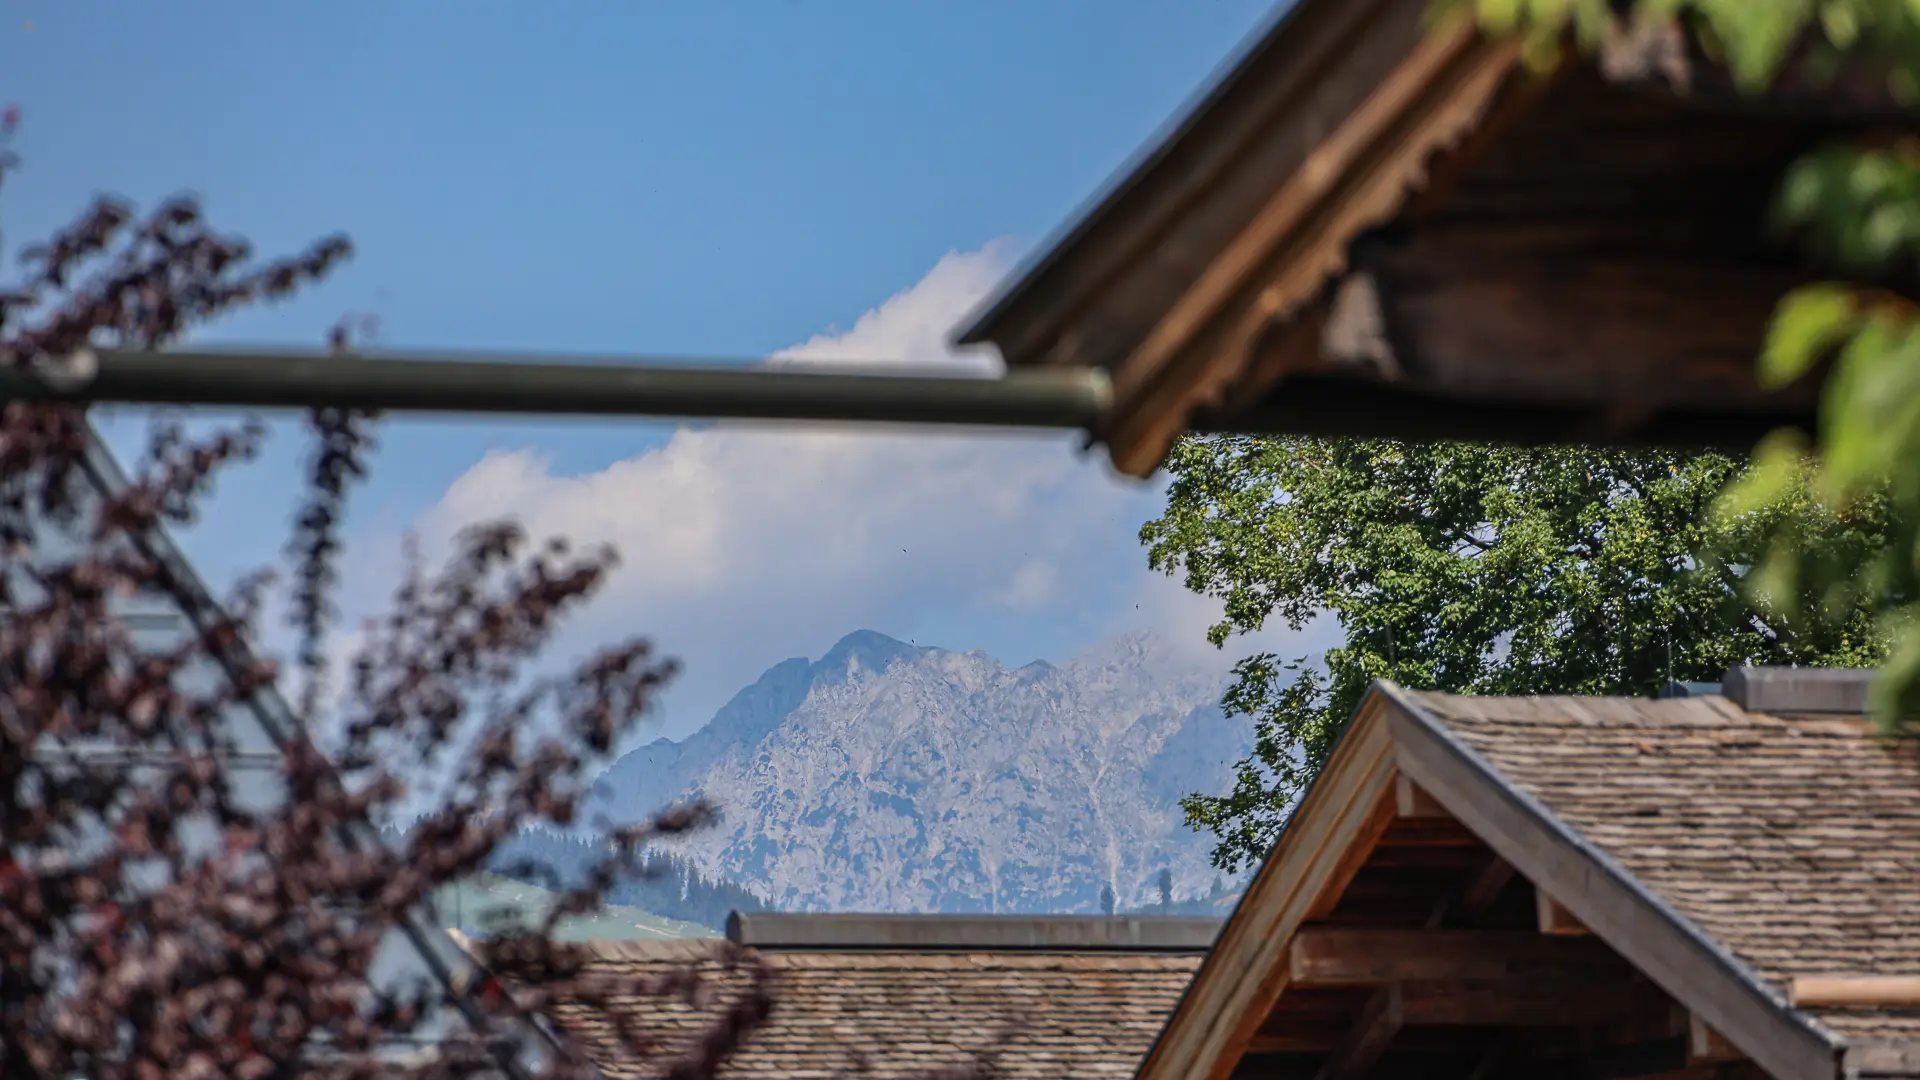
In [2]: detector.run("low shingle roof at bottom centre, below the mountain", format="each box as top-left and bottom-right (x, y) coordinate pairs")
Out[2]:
(509, 940), (1202, 1080)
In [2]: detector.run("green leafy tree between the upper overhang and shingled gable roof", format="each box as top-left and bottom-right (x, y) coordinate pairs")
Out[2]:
(1140, 436), (1884, 872)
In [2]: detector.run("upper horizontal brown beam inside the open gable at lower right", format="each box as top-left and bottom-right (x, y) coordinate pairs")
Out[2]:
(1288, 926), (1632, 988)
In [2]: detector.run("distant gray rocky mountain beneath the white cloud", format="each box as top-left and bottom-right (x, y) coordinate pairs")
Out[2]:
(589, 630), (1252, 913)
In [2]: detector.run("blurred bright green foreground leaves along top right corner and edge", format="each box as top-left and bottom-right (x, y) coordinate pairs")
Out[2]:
(1436, 0), (1920, 726)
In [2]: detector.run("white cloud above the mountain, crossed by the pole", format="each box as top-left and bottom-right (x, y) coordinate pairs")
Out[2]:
(395, 246), (1313, 732)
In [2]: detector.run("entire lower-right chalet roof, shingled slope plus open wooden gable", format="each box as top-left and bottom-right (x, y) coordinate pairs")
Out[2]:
(1142, 669), (1920, 1078)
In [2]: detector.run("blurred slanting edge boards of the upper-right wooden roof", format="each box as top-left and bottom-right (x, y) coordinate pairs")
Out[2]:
(958, 0), (1521, 477)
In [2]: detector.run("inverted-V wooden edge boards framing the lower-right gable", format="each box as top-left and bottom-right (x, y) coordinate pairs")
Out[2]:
(1139, 680), (1843, 1080)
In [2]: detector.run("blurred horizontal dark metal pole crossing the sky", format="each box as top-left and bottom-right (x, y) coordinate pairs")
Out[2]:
(0, 350), (1112, 429)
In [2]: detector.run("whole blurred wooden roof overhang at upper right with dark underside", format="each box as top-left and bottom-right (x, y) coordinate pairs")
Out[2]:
(960, 0), (1920, 477)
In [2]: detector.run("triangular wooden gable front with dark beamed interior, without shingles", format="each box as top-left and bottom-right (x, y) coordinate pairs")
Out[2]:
(1139, 682), (1866, 1080)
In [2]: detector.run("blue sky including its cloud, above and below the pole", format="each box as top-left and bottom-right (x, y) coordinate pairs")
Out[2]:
(0, 0), (1313, 734)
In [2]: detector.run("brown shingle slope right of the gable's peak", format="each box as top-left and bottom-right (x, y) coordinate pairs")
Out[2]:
(1411, 694), (1920, 1042)
